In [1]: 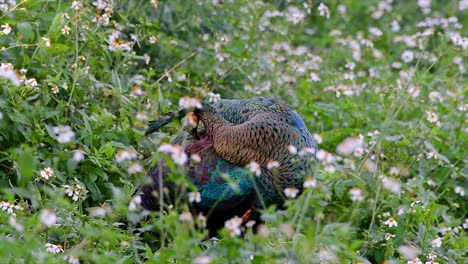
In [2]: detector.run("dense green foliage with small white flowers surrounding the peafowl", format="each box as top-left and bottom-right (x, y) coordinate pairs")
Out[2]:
(0, 0), (468, 263)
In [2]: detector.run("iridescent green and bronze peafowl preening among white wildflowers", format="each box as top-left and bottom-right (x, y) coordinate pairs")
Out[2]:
(141, 97), (316, 236)
